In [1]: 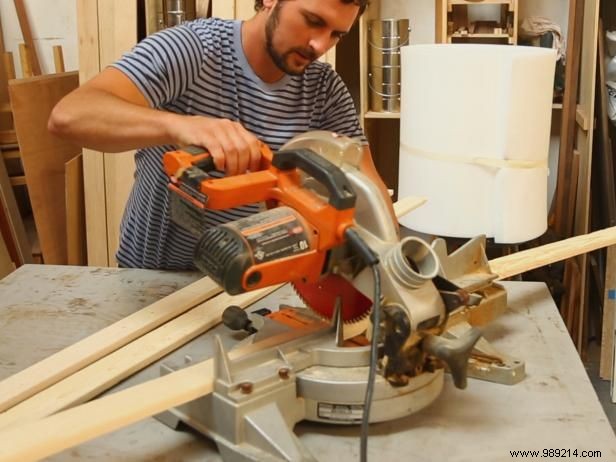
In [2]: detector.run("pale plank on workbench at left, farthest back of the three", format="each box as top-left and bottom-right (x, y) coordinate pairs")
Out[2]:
(0, 278), (221, 412)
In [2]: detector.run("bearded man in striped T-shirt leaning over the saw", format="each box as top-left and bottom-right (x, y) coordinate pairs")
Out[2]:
(49, 0), (386, 269)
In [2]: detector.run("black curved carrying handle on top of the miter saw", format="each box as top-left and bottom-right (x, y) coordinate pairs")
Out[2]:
(272, 149), (357, 210)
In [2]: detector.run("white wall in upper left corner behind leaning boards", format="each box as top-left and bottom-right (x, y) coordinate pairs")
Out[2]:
(0, 0), (79, 78)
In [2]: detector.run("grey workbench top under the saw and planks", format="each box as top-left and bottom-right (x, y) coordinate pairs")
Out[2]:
(0, 265), (616, 462)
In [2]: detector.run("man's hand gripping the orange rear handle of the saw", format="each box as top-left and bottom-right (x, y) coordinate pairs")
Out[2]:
(171, 116), (261, 175)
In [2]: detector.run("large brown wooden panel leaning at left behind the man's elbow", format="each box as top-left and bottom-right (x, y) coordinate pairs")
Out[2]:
(9, 72), (81, 265)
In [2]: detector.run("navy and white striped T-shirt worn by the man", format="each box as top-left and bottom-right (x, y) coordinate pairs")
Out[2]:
(113, 18), (363, 269)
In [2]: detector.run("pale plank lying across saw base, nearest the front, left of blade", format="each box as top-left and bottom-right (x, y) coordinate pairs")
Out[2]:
(0, 323), (324, 462)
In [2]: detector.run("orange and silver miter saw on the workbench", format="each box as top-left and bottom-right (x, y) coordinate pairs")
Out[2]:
(164, 131), (523, 461)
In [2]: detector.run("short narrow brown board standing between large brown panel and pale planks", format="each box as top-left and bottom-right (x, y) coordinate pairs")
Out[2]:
(64, 154), (88, 266)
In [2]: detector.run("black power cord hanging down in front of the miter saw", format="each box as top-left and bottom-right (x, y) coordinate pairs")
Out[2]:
(345, 228), (381, 462)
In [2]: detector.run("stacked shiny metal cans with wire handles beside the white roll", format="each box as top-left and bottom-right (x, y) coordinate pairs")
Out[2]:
(368, 19), (411, 112)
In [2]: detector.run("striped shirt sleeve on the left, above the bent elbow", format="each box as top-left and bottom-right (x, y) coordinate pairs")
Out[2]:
(112, 25), (203, 108)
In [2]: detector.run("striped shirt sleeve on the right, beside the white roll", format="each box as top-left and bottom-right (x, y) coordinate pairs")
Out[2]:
(320, 69), (367, 143)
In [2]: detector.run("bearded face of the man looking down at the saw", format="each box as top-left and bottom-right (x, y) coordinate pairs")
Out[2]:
(265, 0), (359, 75)
